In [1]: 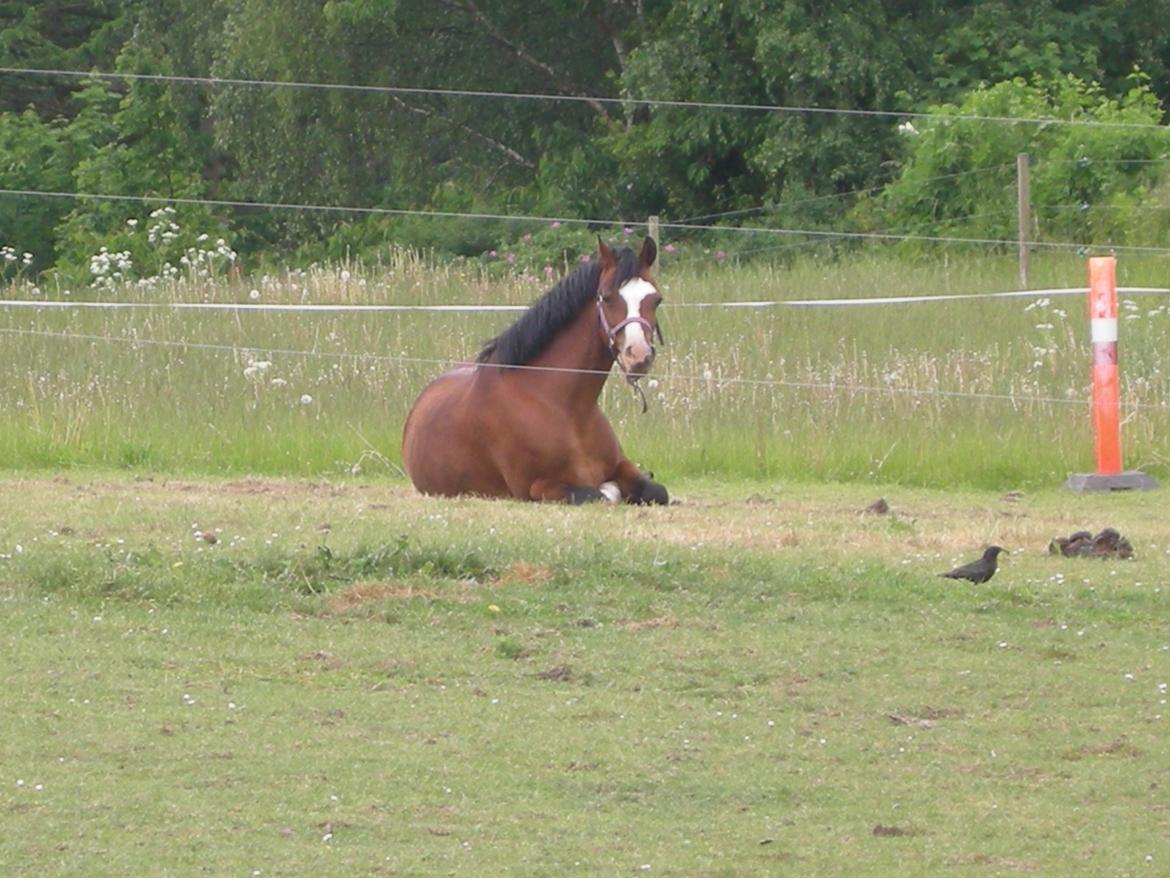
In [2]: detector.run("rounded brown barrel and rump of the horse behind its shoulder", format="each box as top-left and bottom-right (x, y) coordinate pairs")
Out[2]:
(402, 366), (509, 496)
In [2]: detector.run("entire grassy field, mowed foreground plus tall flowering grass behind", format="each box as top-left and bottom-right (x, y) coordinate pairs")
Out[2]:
(0, 224), (1170, 876)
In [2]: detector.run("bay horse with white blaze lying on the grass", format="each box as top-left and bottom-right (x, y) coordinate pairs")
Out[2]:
(402, 238), (668, 503)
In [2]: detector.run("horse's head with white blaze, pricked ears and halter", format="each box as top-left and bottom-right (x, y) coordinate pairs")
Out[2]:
(597, 238), (662, 384)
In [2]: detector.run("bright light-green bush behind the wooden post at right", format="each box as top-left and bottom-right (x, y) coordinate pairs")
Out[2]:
(879, 74), (1170, 242)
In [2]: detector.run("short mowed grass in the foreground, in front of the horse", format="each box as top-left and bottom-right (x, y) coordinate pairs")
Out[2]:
(0, 474), (1170, 876)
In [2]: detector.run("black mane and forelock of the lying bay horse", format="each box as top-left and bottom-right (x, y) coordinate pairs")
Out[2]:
(475, 247), (638, 365)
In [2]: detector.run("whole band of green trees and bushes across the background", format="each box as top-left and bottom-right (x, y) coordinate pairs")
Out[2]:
(9, 0), (1170, 275)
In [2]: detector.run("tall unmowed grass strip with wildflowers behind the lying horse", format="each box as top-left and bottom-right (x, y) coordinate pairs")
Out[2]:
(0, 245), (1170, 488)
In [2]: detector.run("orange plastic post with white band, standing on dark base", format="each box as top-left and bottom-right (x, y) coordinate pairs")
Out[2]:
(1089, 256), (1121, 475)
